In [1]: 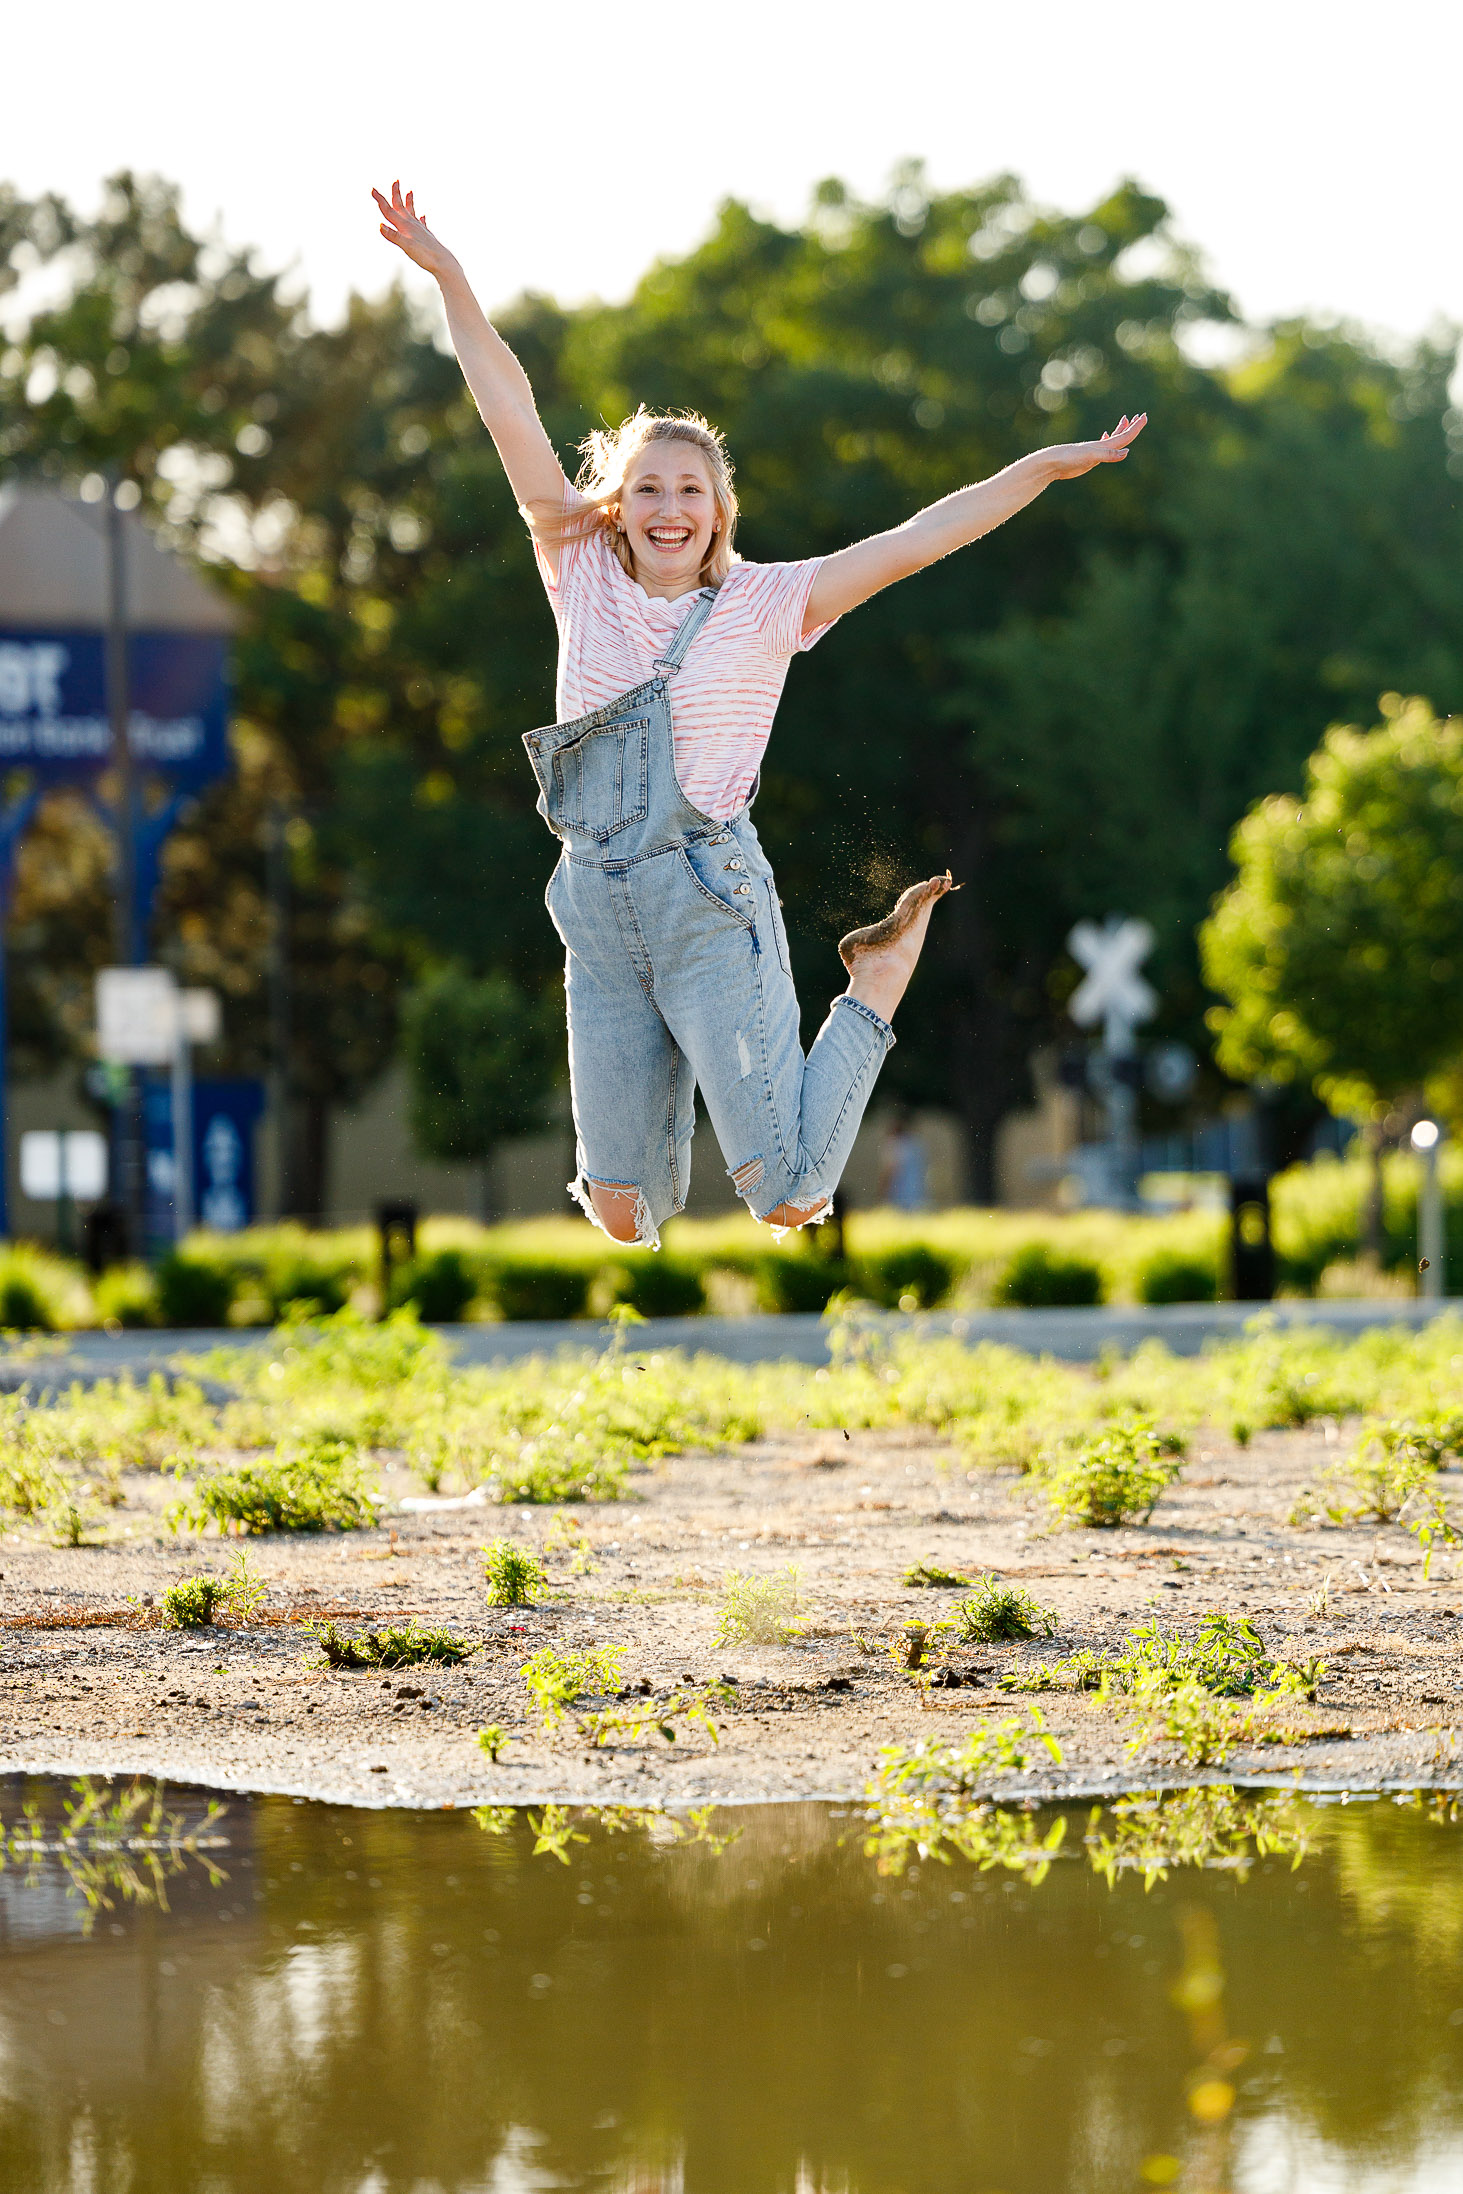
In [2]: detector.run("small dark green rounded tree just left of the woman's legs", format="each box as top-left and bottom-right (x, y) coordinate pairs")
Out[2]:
(401, 965), (564, 1215)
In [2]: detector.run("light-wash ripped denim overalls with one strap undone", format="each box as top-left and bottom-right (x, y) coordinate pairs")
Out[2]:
(524, 588), (895, 1246)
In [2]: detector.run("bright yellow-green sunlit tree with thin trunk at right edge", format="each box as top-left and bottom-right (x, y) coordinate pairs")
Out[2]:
(1200, 693), (1463, 1235)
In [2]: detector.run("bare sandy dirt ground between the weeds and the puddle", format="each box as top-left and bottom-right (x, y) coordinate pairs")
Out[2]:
(0, 1426), (1463, 1808)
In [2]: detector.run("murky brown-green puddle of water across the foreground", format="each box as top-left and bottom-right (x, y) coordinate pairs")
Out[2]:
(0, 1782), (1463, 2194)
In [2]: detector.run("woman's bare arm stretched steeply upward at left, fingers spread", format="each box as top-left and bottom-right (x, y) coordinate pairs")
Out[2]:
(371, 182), (568, 524)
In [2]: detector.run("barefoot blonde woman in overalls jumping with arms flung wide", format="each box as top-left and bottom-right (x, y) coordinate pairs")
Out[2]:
(371, 184), (1145, 1248)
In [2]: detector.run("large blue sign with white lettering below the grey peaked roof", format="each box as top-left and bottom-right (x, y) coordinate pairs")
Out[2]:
(0, 630), (228, 788)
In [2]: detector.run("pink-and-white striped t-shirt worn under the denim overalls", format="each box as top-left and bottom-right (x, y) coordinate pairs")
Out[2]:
(535, 513), (833, 823)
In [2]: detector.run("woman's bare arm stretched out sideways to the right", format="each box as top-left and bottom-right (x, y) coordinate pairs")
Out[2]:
(803, 412), (1147, 632)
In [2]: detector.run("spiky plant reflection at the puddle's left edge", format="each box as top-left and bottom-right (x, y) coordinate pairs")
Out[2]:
(0, 1775), (226, 1935)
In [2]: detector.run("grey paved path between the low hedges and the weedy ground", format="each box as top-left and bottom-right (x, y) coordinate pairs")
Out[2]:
(0, 1297), (1463, 1391)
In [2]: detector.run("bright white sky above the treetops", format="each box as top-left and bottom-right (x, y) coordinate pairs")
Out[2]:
(11, 0), (1463, 336)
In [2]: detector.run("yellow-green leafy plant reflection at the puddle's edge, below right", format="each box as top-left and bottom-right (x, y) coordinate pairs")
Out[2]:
(1081, 1784), (1314, 1889)
